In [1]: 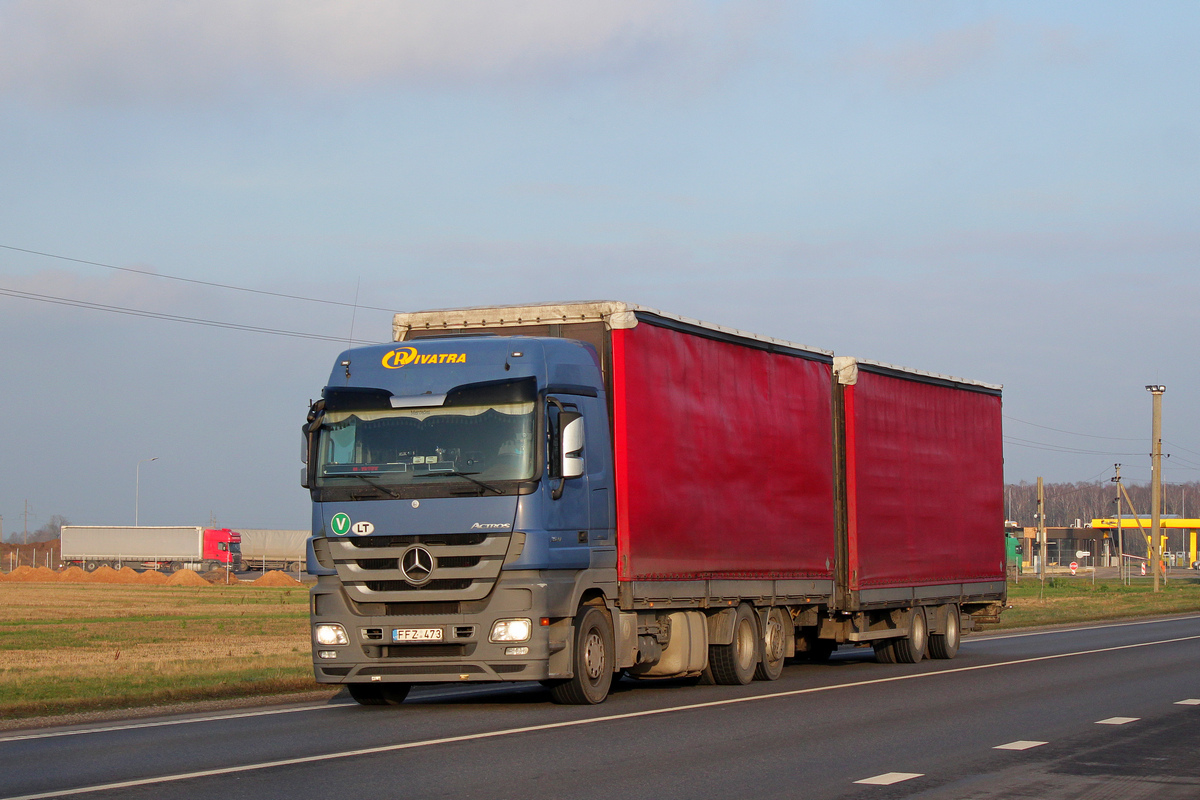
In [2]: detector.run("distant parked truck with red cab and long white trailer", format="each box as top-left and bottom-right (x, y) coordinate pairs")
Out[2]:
(61, 525), (241, 572)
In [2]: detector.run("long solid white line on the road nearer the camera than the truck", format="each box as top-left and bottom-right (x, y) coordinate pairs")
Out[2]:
(0, 634), (1200, 800)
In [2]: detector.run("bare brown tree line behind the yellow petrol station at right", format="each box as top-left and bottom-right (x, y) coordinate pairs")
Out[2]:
(1004, 481), (1200, 528)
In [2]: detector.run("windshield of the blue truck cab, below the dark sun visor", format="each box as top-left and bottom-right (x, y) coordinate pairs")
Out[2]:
(317, 381), (535, 488)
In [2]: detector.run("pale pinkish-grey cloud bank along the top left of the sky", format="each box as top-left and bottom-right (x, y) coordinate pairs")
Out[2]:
(0, 0), (769, 102)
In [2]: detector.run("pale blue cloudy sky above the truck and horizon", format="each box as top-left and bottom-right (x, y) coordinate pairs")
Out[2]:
(0, 0), (1200, 536)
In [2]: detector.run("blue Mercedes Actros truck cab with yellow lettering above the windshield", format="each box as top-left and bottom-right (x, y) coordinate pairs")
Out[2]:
(302, 335), (617, 704)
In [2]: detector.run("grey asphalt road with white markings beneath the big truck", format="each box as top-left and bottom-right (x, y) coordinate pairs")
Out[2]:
(0, 615), (1200, 800)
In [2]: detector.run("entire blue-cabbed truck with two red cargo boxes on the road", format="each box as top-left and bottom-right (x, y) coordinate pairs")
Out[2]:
(301, 301), (1006, 704)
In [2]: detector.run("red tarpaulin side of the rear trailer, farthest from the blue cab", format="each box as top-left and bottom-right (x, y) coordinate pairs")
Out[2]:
(844, 362), (1004, 600)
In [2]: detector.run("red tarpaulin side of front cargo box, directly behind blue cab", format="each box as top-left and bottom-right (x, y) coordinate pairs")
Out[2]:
(611, 318), (835, 581)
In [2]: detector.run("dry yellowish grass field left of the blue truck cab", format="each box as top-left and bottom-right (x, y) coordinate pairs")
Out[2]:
(0, 582), (318, 720)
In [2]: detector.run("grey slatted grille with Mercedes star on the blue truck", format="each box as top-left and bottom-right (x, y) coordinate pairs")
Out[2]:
(325, 530), (510, 604)
